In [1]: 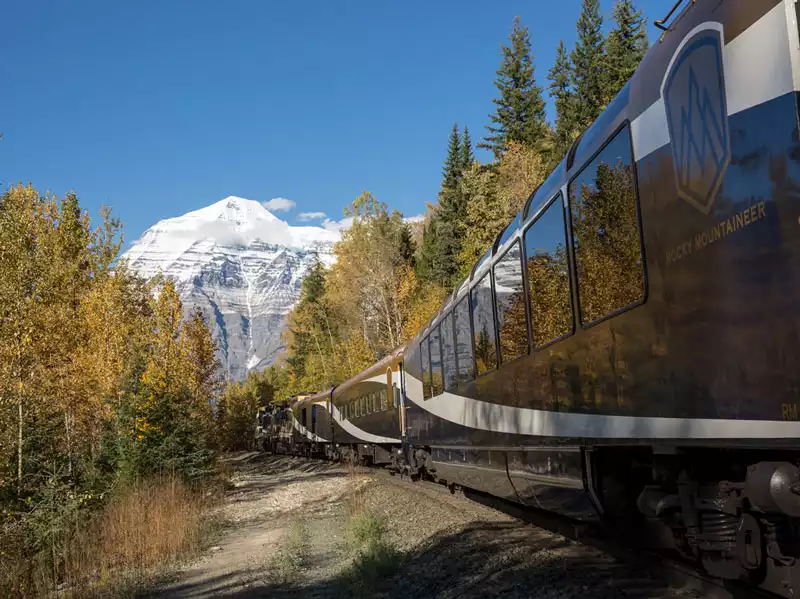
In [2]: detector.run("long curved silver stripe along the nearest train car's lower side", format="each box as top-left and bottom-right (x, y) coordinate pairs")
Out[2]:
(406, 372), (800, 439)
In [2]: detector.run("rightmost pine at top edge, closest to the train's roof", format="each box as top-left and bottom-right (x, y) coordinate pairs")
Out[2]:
(604, 0), (647, 102)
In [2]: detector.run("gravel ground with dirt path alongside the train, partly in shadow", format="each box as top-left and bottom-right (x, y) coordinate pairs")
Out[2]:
(142, 454), (693, 599)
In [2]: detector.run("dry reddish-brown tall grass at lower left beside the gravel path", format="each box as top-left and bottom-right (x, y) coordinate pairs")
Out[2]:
(0, 476), (215, 598)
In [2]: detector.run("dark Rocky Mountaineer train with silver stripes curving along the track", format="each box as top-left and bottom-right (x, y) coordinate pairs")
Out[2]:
(256, 0), (800, 598)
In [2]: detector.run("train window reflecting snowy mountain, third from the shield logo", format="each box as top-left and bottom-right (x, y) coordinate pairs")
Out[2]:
(494, 241), (528, 362)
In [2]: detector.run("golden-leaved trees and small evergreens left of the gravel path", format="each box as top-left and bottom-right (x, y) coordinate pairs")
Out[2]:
(0, 186), (222, 594)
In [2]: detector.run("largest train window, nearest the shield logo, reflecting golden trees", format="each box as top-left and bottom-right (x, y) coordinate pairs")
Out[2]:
(569, 126), (644, 323)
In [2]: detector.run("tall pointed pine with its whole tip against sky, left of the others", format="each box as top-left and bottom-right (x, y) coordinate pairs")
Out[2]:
(479, 17), (547, 159)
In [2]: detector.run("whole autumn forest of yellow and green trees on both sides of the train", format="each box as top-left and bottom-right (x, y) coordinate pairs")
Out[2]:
(0, 0), (647, 596)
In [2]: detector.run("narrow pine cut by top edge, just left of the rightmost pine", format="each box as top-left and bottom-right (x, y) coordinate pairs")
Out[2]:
(571, 0), (606, 129)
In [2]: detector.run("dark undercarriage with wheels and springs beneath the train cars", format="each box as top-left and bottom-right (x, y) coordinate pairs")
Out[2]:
(260, 436), (800, 597)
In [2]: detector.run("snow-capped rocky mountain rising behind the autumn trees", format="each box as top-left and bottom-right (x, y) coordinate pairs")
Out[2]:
(123, 196), (339, 380)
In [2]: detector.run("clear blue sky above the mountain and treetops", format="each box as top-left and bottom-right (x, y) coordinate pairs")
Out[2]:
(0, 0), (673, 245)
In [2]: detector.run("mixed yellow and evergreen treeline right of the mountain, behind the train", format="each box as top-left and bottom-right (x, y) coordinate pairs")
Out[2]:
(252, 0), (648, 408)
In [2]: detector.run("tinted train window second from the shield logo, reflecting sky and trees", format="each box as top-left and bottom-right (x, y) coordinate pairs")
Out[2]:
(525, 194), (572, 347)
